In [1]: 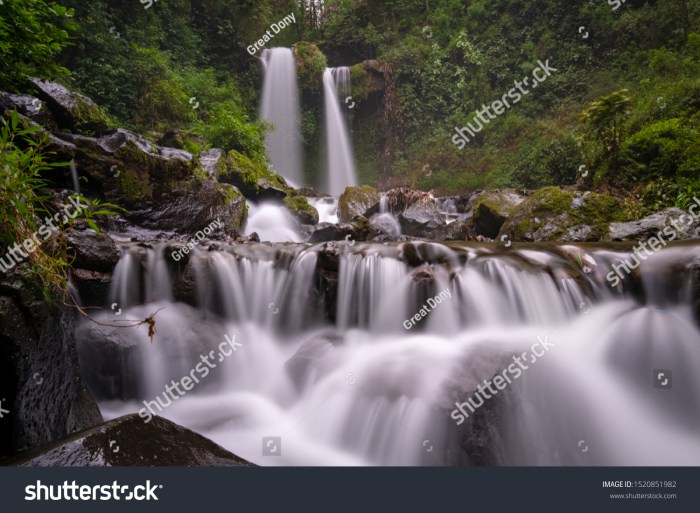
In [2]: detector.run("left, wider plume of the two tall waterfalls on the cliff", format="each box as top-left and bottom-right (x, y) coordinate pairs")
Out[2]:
(261, 48), (304, 187)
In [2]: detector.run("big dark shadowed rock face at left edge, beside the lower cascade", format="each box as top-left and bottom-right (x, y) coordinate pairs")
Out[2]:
(0, 269), (102, 456)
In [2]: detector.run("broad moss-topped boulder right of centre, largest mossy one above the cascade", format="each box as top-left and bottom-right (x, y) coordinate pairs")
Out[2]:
(498, 187), (624, 242)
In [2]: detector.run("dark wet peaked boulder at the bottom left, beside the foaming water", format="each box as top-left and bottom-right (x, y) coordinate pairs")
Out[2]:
(4, 415), (253, 466)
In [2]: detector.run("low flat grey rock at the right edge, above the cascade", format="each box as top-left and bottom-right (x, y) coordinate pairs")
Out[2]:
(603, 208), (700, 242)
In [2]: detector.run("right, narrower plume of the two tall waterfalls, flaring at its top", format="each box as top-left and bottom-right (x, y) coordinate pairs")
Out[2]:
(323, 68), (357, 196)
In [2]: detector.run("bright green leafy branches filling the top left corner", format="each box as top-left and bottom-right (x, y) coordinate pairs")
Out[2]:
(0, 0), (76, 91)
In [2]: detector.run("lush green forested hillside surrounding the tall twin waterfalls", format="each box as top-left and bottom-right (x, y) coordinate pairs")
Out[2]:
(0, 0), (700, 209)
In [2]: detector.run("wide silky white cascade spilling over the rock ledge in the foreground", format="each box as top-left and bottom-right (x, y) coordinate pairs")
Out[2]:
(77, 243), (700, 466)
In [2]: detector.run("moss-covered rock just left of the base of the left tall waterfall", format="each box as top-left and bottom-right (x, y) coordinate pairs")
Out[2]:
(224, 150), (293, 201)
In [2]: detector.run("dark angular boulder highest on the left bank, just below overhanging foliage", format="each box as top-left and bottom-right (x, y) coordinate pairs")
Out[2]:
(31, 78), (110, 133)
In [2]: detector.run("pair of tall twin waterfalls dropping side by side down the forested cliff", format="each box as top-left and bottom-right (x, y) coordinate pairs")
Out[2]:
(261, 48), (357, 195)
